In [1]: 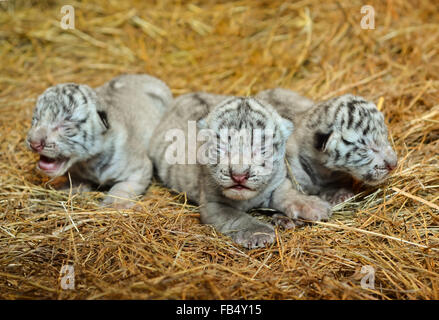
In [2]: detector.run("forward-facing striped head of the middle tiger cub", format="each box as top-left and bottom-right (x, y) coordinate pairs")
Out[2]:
(198, 97), (293, 200)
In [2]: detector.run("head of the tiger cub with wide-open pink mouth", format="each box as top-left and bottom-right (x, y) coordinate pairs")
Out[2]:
(26, 83), (108, 177)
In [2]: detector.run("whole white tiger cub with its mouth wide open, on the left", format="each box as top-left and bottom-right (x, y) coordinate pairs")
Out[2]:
(26, 75), (172, 208)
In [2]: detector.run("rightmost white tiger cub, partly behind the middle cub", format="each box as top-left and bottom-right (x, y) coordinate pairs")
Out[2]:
(256, 88), (398, 205)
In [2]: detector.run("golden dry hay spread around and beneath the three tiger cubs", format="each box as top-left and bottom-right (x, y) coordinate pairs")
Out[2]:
(0, 0), (439, 299)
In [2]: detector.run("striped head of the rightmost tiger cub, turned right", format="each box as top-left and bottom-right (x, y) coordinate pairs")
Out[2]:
(307, 94), (398, 185)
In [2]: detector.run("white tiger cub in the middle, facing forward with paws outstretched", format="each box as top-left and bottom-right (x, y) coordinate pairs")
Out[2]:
(149, 93), (331, 248)
